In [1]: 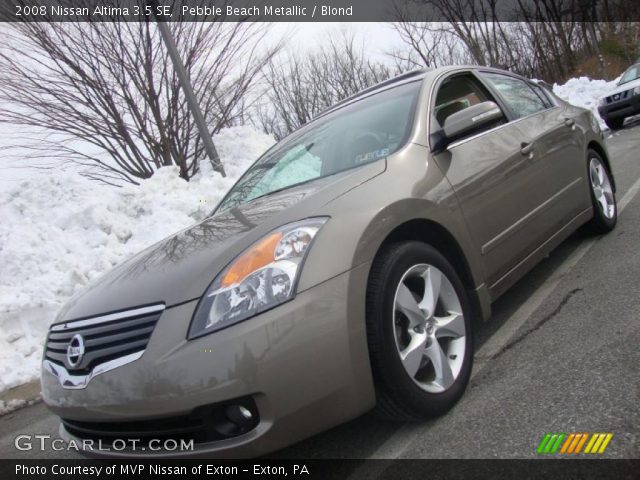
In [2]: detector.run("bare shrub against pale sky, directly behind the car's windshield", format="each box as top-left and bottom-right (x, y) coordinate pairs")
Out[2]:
(254, 33), (394, 139)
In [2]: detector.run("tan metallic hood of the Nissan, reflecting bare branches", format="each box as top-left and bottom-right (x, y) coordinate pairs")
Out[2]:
(57, 160), (386, 321)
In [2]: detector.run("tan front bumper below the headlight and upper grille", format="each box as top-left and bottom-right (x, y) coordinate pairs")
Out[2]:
(42, 264), (375, 458)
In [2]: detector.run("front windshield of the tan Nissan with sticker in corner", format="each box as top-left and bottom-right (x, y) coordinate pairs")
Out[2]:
(216, 81), (421, 211)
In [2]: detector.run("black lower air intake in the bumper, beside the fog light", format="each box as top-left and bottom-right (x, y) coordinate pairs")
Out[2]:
(61, 397), (260, 445)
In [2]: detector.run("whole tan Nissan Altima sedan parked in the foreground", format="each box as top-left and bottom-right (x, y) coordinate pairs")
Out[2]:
(42, 67), (617, 457)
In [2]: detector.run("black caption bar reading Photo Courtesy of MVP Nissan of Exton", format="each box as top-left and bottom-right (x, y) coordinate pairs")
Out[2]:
(0, 459), (640, 480)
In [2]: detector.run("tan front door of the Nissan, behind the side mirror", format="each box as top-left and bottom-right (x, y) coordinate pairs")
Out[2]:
(431, 72), (555, 294)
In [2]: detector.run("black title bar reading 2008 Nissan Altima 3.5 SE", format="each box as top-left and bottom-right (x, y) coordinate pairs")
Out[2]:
(0, 0), (640, 22)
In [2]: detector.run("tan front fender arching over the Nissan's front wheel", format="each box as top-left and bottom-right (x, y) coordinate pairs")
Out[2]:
(298, 144), (484, 291)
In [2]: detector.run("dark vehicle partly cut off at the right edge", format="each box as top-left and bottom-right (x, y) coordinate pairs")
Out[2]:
(598, 63), (640, 130)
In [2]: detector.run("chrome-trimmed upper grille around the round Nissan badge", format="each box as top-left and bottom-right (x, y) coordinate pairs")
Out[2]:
(44, 305), (164, 374)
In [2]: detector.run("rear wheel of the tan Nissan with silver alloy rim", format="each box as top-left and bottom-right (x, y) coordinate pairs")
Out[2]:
(587, 150), (618, 233)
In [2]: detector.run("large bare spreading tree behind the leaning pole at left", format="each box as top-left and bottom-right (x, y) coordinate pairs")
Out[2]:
(0, 16), (280, 184)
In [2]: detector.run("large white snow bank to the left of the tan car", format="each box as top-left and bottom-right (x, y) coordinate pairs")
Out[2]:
(0, 127), (274, 391)
